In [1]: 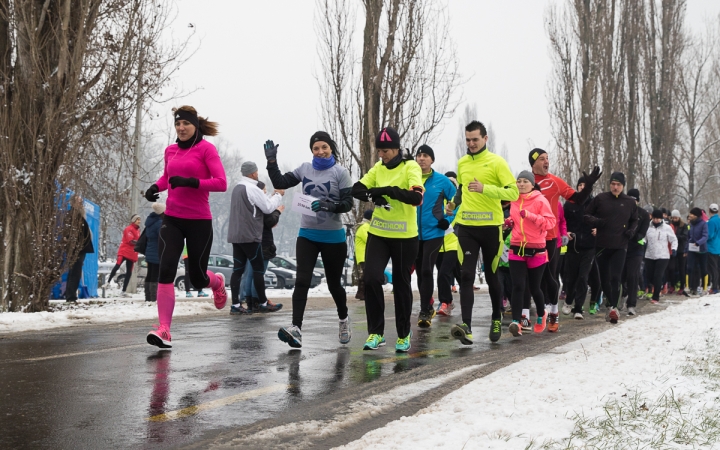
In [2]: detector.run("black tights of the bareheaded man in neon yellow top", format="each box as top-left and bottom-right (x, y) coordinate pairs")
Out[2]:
(457, 225), (502, 327)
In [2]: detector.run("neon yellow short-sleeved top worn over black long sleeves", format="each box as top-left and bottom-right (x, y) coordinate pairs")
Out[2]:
(360, 161), (423, 239)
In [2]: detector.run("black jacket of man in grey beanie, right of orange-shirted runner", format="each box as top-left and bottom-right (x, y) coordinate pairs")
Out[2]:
(584, 192), (647, 249)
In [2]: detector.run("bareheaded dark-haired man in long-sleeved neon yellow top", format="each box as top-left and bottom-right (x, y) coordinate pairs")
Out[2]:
(448, 120), (519, 345)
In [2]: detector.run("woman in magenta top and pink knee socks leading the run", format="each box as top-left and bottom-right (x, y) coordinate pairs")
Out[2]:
(145, 106), (227, 348)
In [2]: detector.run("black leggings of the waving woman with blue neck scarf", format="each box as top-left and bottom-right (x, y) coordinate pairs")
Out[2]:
(292, 237), (348, 328)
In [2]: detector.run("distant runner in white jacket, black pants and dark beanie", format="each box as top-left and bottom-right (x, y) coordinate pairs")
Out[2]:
(644, 209), (677, 306)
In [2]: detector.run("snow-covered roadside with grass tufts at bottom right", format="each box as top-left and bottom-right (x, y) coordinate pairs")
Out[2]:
(342, 296), (720, 449)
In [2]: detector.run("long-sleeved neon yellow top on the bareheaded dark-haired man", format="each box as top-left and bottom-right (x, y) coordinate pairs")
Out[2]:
(455, 150), (520, 227)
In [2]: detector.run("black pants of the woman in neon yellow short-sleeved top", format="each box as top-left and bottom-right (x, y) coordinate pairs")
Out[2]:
(365, 233), (418, 338)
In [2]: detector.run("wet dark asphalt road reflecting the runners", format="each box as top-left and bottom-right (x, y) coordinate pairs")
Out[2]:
(0, 295), (680, 448)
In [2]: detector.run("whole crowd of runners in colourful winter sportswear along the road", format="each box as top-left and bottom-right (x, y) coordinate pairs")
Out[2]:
(134, 106), (720, 352)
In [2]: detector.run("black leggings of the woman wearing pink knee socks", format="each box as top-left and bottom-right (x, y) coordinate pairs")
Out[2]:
(158, 214), (213, 290)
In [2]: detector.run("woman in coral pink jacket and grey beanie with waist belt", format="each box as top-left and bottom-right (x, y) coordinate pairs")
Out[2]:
(507, 170), (557, 336)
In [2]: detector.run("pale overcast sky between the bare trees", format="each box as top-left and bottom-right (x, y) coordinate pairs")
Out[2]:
(149, 0), (720, 178)
